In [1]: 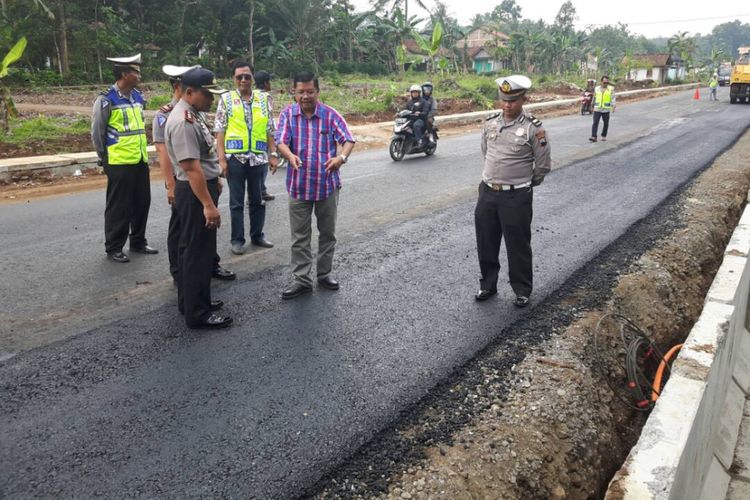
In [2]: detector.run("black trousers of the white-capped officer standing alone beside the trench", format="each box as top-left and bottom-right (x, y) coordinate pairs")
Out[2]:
(474, 183), (533, 297)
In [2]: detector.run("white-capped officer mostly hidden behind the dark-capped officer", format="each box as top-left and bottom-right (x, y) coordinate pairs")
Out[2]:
(152, 64), (237, 284)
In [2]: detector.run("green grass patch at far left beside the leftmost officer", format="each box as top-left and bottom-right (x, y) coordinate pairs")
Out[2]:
(0, 115), (91, 144)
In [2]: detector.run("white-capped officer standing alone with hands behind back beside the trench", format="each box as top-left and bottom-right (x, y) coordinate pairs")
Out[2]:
(474, 75), (551, 307)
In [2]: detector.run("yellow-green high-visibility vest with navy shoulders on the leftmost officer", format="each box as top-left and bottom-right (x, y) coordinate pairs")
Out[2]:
(104, 87), (148, 165)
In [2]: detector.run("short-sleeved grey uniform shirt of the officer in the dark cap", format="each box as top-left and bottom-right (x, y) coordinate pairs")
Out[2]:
(164, 99), (221, 181)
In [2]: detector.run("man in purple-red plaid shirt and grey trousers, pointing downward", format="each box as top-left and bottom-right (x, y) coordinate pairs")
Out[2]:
(276, 73), (355, 299)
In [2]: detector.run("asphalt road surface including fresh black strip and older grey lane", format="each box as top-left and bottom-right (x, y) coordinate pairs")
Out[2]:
(0, 92), (750, 499)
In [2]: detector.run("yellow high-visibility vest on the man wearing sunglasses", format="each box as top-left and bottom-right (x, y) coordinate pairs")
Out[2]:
(223, 90), (269, 154)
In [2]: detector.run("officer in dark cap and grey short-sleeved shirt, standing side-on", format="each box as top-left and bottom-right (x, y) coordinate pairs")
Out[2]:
(164, 68), (232, 328)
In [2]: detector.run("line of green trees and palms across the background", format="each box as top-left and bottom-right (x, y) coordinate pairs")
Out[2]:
(0, 0), (750, 84)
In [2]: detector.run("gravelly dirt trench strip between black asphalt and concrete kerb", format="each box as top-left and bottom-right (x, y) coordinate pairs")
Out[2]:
(303, 132), (750, 500)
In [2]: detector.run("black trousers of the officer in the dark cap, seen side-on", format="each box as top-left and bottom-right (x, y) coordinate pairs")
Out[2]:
(174, 179), (219, 326)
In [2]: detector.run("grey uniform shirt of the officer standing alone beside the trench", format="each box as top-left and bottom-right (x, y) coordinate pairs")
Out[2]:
(482, 113), (551, 185)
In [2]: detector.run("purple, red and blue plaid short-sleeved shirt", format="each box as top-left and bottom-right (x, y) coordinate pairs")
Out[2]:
(276, 103), (354, 201)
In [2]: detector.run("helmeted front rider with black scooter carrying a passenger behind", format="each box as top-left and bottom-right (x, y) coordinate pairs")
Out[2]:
(388, 85), (437, 161)
